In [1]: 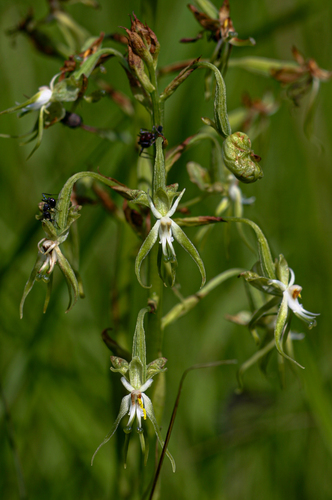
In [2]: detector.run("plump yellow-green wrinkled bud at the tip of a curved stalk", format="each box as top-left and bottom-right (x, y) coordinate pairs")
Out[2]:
(222, 132), (263, 184)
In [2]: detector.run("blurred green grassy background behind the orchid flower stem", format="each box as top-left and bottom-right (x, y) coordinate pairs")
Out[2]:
(0, 0), (332, 500)
